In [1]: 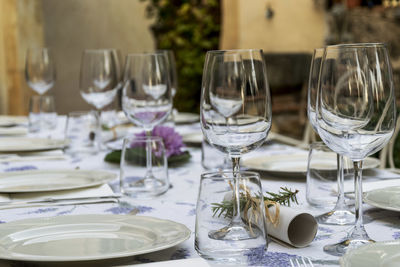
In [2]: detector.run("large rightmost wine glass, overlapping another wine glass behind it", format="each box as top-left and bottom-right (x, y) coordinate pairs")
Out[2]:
(317, 43), (396, 255)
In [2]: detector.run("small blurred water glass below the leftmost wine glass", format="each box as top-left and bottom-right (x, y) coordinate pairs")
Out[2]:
(29, 95), (57, 132)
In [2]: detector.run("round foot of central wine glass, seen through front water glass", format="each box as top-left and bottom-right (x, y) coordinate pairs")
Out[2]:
(208, 222), (261, 241)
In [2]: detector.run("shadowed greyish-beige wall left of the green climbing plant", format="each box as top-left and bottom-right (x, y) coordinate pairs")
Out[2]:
(41, 0), (154, 114)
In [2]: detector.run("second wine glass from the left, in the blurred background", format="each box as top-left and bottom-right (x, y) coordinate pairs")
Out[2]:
(79, 49), (121, 149)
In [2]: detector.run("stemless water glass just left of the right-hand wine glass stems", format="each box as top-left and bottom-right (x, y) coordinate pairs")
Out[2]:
(306, 142), (353, 208)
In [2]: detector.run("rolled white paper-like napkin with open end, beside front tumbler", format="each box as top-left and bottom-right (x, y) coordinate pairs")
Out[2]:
(267, 205), (318, 248)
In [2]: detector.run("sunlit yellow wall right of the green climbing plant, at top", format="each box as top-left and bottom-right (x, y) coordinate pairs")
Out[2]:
(221, 0), (326, 52)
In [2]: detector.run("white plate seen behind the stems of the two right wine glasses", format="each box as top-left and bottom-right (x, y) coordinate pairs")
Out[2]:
(243, 153), (380, 176)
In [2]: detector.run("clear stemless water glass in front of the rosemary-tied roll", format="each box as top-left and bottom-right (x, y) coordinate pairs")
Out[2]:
(195, 171), (268, 265)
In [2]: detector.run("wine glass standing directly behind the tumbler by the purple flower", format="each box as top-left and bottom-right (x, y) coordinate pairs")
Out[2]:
(122, 52), (172, 196)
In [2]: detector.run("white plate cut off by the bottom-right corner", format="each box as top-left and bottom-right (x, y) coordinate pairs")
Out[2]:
(340, 241), (400, 267)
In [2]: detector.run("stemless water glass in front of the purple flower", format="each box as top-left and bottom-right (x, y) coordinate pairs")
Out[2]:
(120, 136), (169, 198)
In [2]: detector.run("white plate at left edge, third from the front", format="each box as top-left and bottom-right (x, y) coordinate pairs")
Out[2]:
(0, 137), (68, 153)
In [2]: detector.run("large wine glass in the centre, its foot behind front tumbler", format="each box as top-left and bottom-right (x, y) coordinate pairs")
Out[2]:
(200, 49), (271, 240)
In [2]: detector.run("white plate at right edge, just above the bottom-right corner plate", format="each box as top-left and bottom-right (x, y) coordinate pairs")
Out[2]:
(364, 186), (400, 211)
